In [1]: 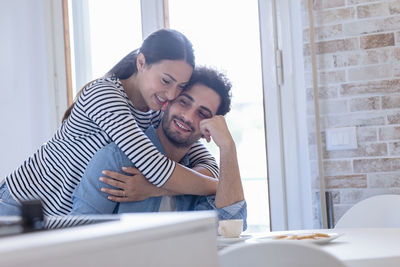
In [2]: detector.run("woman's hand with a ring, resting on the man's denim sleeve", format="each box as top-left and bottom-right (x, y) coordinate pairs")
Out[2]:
(100, 167), (166, 202)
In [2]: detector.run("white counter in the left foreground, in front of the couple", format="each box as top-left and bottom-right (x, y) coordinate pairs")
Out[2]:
(0, 211), (218, 267)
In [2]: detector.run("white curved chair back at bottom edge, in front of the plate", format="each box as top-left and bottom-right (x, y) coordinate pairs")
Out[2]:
(219, 240), (345, 267)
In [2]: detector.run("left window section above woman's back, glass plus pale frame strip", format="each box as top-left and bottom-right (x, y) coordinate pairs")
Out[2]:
(69, 0), (142, 94)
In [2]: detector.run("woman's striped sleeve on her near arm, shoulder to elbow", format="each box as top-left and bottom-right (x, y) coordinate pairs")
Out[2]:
(78, 82), (176, 187)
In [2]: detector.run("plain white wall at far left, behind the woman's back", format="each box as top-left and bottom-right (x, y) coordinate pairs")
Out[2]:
(0, 0), (64, 180)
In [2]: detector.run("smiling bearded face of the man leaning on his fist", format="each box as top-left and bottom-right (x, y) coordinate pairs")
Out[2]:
(161, 83), (221, 147)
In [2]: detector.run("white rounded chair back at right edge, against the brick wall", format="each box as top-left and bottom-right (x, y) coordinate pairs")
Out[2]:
(335, 195), (400, 228)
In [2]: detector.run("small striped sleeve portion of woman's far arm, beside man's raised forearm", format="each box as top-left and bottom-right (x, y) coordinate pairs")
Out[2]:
(188, 141), (219, 178)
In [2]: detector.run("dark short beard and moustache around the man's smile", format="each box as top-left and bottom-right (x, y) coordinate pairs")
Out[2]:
(161, 113), (201, 148)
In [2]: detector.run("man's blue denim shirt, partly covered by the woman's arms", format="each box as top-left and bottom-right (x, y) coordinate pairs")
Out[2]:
(71, 127), (247, 230)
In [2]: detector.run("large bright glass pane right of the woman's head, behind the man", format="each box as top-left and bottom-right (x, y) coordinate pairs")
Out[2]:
(169, 0), (269, 231)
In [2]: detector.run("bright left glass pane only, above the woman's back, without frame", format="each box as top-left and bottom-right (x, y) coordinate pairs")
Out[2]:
(88, 0), (142, 79)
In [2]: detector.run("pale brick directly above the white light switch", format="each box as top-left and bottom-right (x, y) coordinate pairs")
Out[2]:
(326, 112), (385, 128)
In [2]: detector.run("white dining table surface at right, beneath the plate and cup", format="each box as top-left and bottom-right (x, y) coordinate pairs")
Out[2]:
(218, 228), (400, 267)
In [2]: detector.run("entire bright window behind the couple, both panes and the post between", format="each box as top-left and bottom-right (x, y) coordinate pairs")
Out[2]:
(69, 0), (269, 231)
